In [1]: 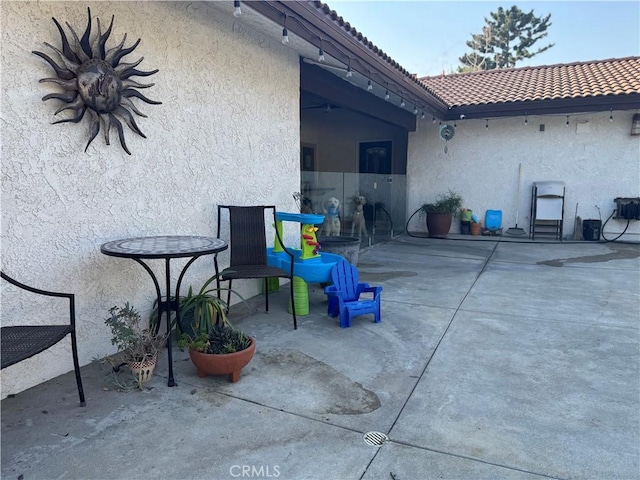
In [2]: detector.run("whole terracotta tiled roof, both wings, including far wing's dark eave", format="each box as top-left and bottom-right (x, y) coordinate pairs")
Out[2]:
(309, 0), (640, 116)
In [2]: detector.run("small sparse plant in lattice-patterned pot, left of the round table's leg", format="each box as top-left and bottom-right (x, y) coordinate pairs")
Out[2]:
(104, 302), (167, 388)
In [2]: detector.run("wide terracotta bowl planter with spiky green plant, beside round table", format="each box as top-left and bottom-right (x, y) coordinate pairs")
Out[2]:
(178, 276), (256, 382)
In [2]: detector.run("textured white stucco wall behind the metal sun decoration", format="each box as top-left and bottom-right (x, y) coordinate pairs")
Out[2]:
(1, 2), (300, 397)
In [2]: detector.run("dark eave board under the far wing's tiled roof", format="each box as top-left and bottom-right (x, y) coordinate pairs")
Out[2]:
(443, 93), (640, 120)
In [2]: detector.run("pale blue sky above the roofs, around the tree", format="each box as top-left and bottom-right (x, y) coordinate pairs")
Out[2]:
(326, 0), (640, 76)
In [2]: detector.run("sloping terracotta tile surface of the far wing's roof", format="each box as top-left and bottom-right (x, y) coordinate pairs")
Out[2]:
(419, 57), (640, 107)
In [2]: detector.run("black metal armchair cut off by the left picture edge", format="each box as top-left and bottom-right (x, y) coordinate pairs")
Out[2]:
(0, 272), (85, 407)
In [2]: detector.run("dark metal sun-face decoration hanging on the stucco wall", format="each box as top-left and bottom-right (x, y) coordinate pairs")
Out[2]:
(32, 8), (162, 155)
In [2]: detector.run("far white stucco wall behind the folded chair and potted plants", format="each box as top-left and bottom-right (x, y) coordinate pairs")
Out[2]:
(407, 111), (640, 242)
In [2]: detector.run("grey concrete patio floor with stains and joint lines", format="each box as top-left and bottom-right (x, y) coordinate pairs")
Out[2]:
(2, 236), (640, 480)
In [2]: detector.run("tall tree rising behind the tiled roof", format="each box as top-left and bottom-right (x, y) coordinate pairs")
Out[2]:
(458, 5), (554, 72)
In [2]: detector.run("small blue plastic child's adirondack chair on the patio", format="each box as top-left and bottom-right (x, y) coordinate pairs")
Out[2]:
(324, 260), (382, 328)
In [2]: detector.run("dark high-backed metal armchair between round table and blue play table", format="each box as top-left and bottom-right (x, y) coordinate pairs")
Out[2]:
(214, 205), (298, 329)
